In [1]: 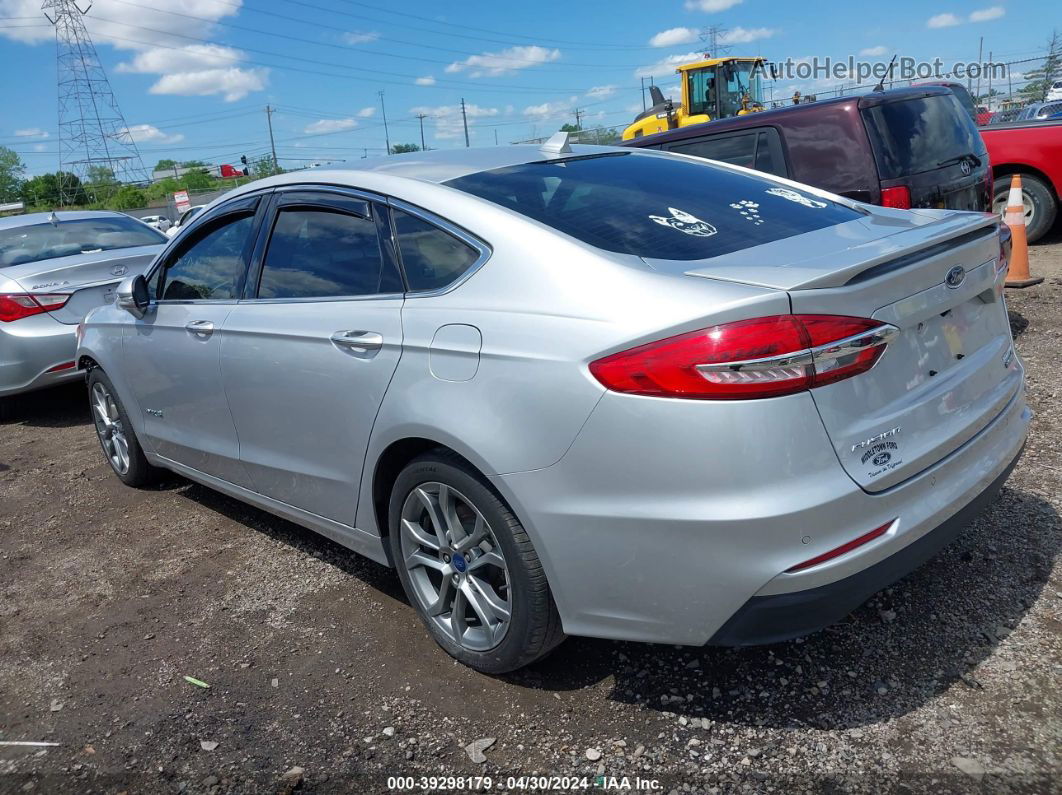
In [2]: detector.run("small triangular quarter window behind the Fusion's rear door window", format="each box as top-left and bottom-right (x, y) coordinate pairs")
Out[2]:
(394, 210), (479, 291)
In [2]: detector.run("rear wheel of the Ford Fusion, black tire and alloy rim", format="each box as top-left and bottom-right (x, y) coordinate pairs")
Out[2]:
(388, 450), (565, 674)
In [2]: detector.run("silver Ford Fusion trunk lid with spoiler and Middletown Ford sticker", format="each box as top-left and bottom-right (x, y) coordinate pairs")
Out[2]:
(649, 210), (1022, 491)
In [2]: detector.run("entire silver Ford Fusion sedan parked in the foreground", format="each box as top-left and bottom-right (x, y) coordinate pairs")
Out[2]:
(78, 140), (1030, 673)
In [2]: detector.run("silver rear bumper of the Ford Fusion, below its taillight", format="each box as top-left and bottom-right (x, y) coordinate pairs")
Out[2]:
(492, 377), (1031, 646)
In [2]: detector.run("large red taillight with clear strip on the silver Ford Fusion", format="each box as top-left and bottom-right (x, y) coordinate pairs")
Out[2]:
(589, 315), (900, 400)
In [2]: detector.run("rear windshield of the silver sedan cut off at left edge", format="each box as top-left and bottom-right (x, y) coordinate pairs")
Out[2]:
(0, 215), (169, 267)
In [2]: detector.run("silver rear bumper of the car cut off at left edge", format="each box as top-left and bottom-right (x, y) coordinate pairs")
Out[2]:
(0, 313), (85, 397)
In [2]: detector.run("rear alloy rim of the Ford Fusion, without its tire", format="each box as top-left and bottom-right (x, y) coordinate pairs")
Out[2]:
(399, 483), (512, 652)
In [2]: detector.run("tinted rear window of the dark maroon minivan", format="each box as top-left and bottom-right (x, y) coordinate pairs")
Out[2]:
(861, 94), (984, 179)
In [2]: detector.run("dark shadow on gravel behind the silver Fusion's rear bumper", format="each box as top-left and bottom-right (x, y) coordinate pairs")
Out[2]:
(506, 488), (1062, 729)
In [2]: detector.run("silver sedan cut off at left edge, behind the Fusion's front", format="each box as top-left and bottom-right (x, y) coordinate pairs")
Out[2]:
(0, 211), (166, 415)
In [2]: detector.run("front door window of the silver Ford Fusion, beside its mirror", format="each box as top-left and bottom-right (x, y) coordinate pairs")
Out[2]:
(155, 214), (254, 300)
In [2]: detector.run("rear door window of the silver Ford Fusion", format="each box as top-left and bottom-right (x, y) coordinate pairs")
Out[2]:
(258, 208), (401, 298)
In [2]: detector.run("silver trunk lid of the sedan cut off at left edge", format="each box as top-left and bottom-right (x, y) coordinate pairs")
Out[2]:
(0, 245), (162, 325)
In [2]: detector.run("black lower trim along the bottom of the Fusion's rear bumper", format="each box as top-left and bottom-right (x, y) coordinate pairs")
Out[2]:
(708, 446), (1025, 646)
